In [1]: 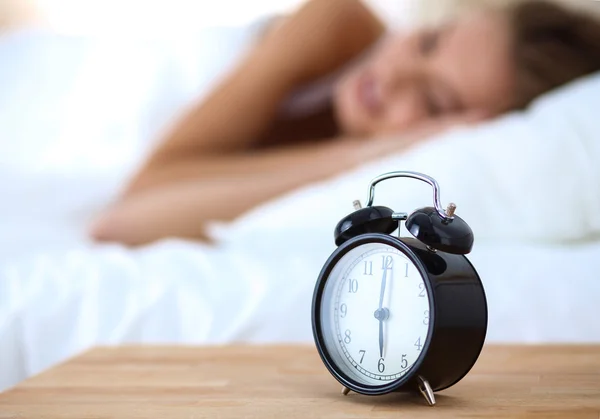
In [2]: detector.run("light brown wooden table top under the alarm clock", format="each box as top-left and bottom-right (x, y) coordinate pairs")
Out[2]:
(0, 346), (600, 419)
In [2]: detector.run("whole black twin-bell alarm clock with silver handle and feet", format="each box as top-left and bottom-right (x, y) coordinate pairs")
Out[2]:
(312, 172), (488, 406)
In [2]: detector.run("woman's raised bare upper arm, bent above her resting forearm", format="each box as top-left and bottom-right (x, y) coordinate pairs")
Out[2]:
(126, 0), (383, 195)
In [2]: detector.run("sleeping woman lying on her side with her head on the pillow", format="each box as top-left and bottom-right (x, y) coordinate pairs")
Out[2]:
(91, 0), (600, 245)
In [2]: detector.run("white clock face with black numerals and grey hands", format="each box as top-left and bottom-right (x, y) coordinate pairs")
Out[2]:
(319, 242), (431, 386)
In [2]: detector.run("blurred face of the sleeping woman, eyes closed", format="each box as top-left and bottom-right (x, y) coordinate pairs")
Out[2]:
(334, 12), (513, 135)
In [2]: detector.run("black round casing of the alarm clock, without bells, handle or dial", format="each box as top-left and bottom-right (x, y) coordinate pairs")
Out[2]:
(312, 233), (488, 395)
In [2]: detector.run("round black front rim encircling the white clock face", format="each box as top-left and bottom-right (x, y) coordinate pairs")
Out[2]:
(311, 233), (437, 396)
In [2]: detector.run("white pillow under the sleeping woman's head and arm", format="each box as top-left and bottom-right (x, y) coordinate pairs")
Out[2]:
(212, 73), (600, 248)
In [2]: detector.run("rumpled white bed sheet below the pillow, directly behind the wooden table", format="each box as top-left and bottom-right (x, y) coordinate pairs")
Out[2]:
(0, 238), (600, 387)
